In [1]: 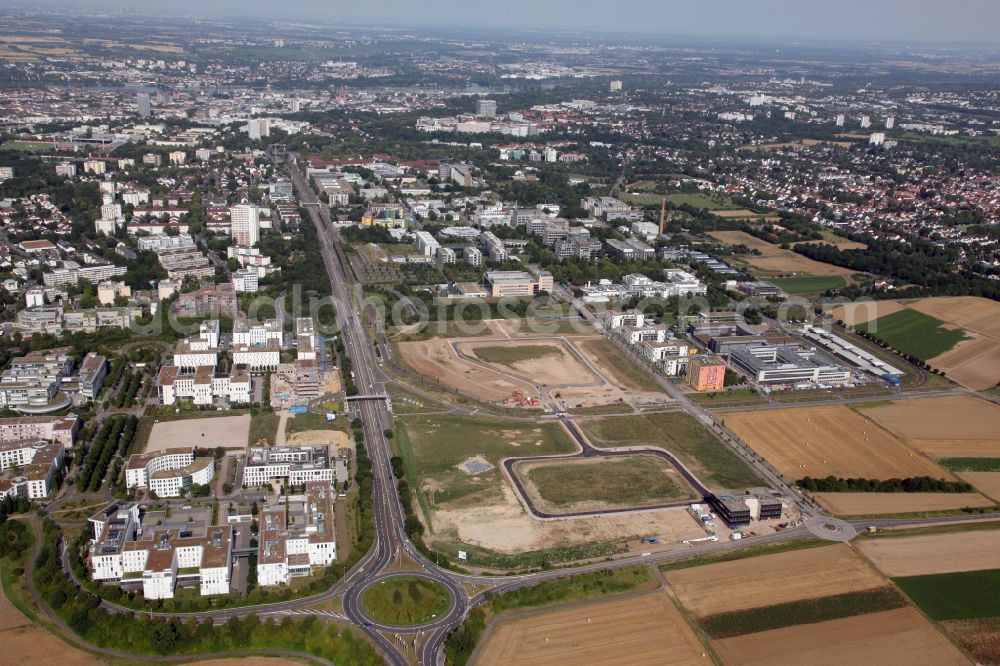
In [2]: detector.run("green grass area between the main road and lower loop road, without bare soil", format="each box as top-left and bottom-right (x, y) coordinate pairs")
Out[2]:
(396, 415), (576, 512)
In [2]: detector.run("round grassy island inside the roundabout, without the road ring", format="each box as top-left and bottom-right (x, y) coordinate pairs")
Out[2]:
(361, 576), (451, 626)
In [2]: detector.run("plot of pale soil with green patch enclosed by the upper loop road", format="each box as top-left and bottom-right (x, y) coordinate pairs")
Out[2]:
(458, 340), (598, 386)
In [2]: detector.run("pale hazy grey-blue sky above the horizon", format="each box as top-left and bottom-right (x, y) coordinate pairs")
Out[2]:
(7, 0), (1000, 45)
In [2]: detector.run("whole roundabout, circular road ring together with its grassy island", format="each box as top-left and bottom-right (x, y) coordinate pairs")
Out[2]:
(344, 571), (467, 633)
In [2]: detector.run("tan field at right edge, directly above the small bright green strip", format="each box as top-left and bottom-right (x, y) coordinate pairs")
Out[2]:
(861, 395), (1000, 458)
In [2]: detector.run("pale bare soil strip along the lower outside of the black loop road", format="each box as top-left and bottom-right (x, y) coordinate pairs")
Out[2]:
(425, 482), (705, 554)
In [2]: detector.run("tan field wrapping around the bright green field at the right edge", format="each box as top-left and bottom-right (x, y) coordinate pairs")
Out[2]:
(833, 296), (1000, 391)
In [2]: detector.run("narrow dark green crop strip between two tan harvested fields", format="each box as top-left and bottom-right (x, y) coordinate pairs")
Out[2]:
(699, 587), (906, 639)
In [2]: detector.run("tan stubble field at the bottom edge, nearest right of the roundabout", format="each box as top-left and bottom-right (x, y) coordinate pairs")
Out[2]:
(476, 592), (710, 666)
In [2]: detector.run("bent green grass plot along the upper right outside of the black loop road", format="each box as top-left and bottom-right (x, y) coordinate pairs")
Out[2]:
(580, 412), (764, 489)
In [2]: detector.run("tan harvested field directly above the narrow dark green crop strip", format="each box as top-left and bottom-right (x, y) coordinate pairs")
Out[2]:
(666, 544), (885, 617)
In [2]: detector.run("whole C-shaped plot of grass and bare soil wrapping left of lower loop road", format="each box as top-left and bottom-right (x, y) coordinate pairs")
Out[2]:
(395, 416), (704, 561)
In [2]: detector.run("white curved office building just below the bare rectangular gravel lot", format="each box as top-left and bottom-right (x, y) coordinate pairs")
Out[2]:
(125, 448), (215, 497)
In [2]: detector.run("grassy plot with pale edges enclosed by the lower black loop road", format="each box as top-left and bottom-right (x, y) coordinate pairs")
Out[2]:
(514, 455), (700, 513)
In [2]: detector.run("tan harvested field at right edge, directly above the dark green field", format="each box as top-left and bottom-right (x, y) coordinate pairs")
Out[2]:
(857, 530), (1000, 576)
